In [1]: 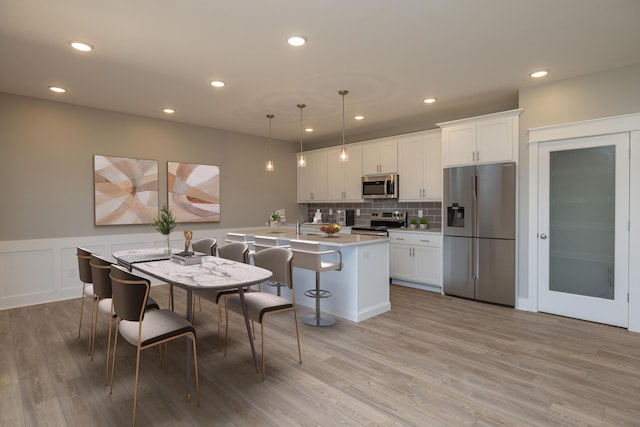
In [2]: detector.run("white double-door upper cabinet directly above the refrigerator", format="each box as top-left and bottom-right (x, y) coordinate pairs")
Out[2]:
(438, 109), (522, 167)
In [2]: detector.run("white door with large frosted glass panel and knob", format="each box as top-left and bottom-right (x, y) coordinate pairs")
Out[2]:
(538, 134), (629, 327)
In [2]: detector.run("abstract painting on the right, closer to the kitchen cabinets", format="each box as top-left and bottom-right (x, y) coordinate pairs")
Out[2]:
(167, 162), (220, 222)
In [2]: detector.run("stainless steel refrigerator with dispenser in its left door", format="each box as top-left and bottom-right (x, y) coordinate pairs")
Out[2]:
(443, 162), (516, 306)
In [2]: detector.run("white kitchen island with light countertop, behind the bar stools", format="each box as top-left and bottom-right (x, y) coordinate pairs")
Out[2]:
(240, 227), (391, 322)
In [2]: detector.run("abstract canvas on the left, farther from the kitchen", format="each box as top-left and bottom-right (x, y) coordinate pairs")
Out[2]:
(93, 155), (158, 225)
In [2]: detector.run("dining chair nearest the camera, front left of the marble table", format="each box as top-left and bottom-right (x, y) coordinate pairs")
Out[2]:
(109, 265), (200, 426)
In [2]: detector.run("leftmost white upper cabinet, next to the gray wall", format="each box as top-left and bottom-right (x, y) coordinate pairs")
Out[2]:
(298, 150), (327, 203)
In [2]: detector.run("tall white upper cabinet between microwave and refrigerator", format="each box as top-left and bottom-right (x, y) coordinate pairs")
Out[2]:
(398, 130), (442, 202)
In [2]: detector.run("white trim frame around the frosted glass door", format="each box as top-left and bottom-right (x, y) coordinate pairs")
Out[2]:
(518, 114), (640, 332)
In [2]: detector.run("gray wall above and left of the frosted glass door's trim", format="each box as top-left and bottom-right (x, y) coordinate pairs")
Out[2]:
(518, 64), (640, 298)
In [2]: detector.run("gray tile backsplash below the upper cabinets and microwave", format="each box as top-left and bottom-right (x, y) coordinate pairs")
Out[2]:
(307, 200), (442, 228)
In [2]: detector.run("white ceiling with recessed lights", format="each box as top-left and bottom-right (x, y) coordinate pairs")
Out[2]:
(0, 0), (640, 142)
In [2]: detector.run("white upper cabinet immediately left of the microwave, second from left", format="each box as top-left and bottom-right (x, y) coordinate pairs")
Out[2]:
(327, 146), (362, 202)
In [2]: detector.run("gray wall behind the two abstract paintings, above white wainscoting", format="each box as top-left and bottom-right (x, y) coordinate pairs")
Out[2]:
(0, 93), (306, 240)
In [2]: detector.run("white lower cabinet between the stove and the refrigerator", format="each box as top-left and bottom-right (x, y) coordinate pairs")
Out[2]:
(389, 231), (442, 287)
